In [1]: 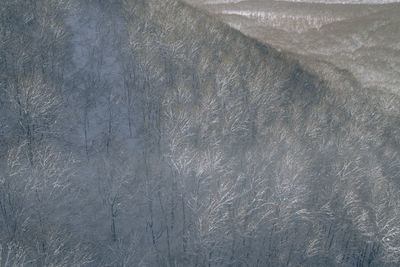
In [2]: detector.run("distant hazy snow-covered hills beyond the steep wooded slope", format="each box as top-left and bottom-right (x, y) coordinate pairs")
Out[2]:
(188, 0), (400, 94)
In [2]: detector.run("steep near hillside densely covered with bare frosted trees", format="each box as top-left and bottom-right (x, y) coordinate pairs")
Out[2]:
(0, 0), (400, 267)
